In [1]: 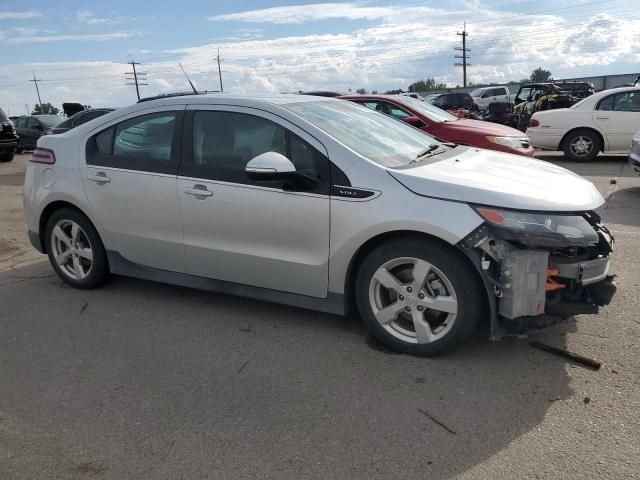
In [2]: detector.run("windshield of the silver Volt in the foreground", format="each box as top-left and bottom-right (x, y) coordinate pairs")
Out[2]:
(284, 100), (439, 167)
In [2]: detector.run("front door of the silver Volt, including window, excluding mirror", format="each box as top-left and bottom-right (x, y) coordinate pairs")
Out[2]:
(178, 105), (330, 298)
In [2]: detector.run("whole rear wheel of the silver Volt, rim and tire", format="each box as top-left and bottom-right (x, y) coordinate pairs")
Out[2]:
(45, 208), (109, 289)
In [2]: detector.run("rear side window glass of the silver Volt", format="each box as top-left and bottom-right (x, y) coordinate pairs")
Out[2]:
(87, 112), (182, 174)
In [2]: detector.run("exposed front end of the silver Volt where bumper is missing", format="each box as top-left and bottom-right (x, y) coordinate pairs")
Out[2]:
(459, 219), (616, 340)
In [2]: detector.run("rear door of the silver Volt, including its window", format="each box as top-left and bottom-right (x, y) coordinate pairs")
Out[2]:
(80, 106), (186, 273)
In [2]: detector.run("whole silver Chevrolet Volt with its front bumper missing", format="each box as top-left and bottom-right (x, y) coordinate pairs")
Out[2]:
(24, 95), (615, 355)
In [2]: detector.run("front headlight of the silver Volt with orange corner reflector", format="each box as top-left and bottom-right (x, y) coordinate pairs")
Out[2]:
(475, 207), (600, 247)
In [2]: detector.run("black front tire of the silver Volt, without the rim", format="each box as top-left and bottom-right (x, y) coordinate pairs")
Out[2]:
(355, 239), (485, 356)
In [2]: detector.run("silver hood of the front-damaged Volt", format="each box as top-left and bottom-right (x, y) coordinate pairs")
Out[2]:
(388, 147), (604, 212)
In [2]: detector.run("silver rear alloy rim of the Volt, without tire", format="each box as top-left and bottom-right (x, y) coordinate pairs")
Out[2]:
(51, 219), (93, 280)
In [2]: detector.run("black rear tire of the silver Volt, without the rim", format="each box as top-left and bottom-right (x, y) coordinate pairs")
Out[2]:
(44, 208), (109, 290)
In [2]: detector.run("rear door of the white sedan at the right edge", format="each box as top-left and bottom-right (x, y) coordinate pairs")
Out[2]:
(593, 90), (640, 151)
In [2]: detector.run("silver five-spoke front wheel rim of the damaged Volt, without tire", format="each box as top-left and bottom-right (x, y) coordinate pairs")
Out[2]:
(369, 257), (458, 344)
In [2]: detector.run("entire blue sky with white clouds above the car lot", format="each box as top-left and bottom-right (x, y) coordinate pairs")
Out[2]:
(0, 0), (640, 114)
